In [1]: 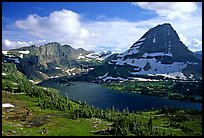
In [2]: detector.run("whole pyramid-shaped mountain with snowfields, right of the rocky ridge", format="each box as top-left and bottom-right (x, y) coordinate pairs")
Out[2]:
(81, 23), (202, 81)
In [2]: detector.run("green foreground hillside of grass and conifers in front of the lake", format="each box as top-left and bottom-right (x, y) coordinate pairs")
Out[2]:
(2, 64), (202, 136)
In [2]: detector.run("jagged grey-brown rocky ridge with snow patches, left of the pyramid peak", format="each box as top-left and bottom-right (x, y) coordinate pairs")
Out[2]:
(3, 42), (111, 80)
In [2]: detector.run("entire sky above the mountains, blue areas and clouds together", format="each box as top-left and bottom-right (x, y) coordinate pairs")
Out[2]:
(2, 2), (202, 52)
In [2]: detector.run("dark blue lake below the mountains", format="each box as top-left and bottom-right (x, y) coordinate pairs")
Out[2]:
(38, 79), (202, 111)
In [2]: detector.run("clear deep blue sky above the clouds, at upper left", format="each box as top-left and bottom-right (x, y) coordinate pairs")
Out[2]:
(2, 2), (156, 21)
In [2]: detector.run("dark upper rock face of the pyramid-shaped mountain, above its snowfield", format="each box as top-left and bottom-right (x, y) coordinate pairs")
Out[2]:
(124, 23), (197, 63)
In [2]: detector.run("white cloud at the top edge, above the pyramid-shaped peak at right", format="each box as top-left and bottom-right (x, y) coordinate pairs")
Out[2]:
(133, 2), (197, 19)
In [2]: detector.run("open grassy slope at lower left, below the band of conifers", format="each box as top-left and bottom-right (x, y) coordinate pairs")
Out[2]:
(2, 91), (111, 136)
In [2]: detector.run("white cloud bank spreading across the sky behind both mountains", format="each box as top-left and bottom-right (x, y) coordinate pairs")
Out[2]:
(2, 2), (202, 52)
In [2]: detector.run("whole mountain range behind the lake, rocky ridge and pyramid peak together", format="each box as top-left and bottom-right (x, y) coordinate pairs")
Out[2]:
(2, 23), (202, 82)
